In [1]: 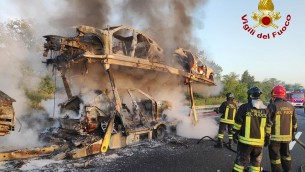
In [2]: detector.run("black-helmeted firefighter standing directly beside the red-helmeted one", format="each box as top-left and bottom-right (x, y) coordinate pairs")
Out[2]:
(233, 87), (272, 172)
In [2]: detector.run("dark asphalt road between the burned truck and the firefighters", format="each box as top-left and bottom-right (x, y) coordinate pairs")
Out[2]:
(95, 109), (305, 172)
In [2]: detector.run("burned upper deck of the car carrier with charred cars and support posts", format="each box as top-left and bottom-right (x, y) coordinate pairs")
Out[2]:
(43, 25), (215, 120)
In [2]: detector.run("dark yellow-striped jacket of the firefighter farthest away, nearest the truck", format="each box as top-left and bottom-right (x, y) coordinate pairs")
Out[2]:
(219, 100), (237, 124)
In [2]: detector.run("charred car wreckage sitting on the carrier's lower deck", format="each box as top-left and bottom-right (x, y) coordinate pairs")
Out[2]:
(80, 89), (174, 138)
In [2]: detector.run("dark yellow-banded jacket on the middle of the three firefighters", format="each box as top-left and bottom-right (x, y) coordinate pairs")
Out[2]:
(233, 103), (272, 146)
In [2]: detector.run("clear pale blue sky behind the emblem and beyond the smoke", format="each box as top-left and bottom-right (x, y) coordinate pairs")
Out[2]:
(0, 0), (305, 87)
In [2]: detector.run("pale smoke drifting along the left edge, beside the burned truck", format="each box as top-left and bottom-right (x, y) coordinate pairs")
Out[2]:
(0, 22), (51, 149)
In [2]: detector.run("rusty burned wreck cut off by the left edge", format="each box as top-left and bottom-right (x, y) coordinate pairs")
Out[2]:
(0, 91), (16, 136)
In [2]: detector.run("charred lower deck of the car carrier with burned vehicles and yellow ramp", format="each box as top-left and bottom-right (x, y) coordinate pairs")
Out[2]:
(62, 89), (178, 158)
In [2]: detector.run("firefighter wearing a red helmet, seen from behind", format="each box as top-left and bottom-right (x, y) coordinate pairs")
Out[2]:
(268, 85), (297, 172)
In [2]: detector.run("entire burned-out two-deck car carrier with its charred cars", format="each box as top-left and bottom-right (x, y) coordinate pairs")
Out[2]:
(38, 25), (215, 158)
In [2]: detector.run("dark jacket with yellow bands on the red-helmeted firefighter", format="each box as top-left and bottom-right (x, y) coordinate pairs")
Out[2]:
(269, 99), (298, 142)
